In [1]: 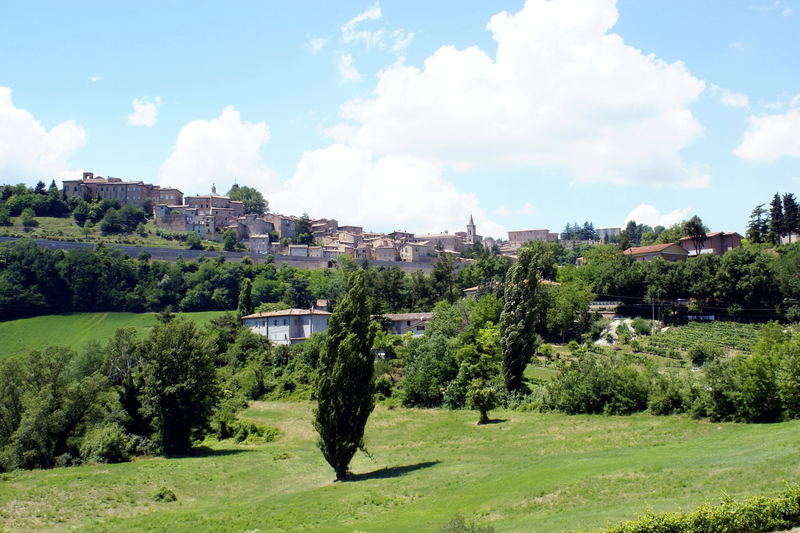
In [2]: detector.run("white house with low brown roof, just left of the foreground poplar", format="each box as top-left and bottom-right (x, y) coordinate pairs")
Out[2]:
(242, 309), (331, 344)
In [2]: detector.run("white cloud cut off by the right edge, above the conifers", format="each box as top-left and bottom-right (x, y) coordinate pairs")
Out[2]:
(733, 108), (800, 163)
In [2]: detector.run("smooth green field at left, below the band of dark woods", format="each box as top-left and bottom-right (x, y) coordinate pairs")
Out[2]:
(0, 311), (228, 358)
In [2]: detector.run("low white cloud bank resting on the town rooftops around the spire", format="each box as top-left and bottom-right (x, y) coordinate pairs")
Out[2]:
(270, 144), (505, 236)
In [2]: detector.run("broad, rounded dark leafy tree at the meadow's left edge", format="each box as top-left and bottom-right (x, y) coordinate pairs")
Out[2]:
(140, 319), (219, 455)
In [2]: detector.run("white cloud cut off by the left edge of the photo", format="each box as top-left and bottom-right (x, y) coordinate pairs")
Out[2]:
(0, 87), (86, 183)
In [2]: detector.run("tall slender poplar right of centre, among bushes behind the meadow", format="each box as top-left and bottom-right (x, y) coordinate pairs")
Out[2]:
(500, 242), (555, 391)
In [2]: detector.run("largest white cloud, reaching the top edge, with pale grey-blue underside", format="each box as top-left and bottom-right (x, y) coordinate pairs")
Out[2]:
(328, 0), (710, 187)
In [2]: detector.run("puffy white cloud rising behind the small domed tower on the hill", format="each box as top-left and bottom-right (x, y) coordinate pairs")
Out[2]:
(158, 106), (278, 194)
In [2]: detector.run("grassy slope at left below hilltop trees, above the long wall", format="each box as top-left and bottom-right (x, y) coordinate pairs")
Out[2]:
(0, 217), (222, 250)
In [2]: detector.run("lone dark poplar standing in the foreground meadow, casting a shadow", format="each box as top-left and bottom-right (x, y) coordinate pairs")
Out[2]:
(313, 271), (375, 480)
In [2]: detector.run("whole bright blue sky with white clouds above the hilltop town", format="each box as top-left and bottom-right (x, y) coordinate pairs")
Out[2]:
(0, 0), (800, 237)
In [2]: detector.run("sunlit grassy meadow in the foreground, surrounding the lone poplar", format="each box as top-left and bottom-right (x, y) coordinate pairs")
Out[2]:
(0, 403), (800, 533)
